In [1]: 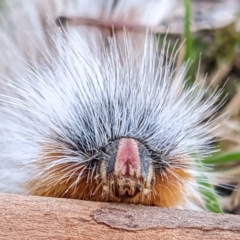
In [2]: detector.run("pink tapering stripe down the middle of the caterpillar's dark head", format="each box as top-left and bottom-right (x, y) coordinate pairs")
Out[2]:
(114, 138), (141, 176)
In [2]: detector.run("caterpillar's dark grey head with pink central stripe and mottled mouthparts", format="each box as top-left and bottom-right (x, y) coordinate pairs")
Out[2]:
(100, 138), (155, 201)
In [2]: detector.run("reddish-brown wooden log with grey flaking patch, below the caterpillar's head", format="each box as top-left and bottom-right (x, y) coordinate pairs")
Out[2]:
(0, 194), (240, 240)
